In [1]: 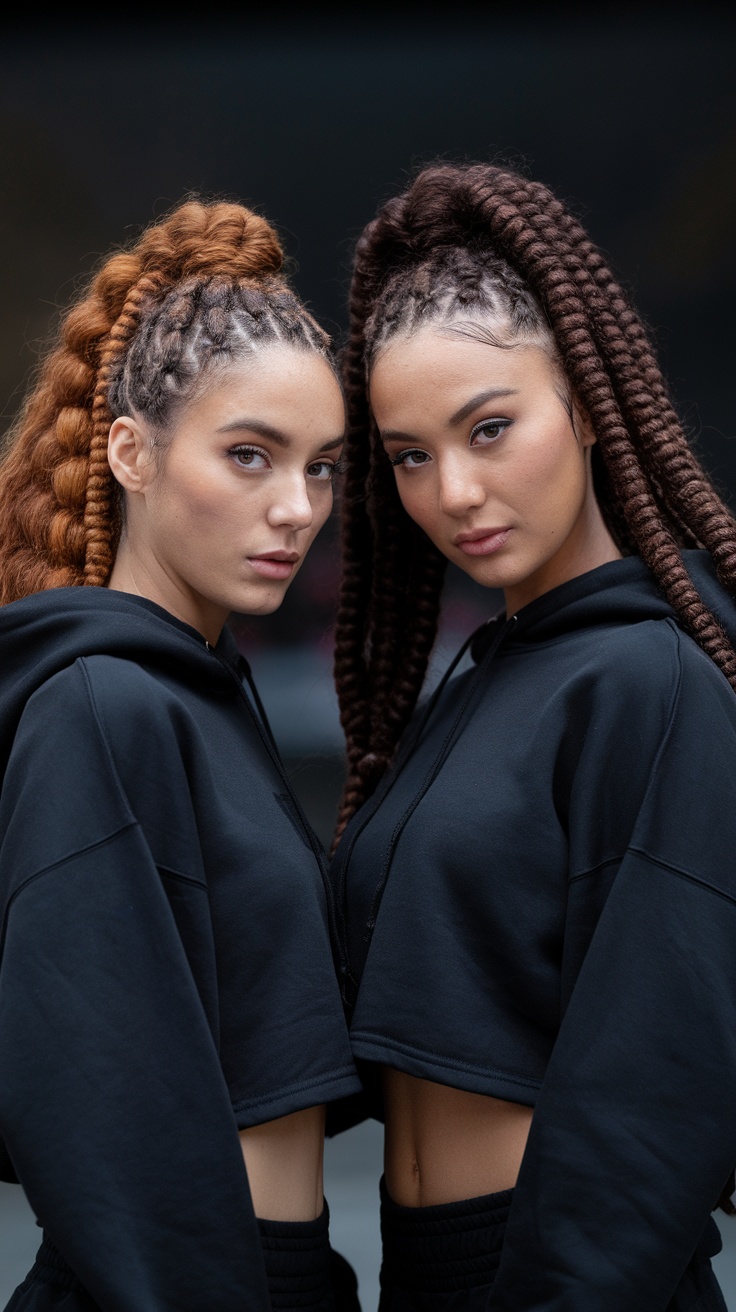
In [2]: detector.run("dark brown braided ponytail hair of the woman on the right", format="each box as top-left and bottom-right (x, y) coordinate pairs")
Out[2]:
(335, 164), (736, 841)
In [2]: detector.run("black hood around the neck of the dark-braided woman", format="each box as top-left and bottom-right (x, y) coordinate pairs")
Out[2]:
(471, 550), (736, 661)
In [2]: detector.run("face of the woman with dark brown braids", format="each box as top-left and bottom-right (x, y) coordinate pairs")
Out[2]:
(370, 327), (619, 614)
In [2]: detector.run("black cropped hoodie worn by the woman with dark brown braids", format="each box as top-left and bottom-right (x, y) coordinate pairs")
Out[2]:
(332, 551), (736, 1312)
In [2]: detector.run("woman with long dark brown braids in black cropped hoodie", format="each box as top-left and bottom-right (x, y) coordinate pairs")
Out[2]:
(332, 164), (736, 1312)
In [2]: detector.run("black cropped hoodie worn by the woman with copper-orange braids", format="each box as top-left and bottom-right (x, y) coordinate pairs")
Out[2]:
(0, 588), (359, 1312)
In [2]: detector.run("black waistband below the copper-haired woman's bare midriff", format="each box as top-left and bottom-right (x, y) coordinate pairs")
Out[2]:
(258, 1203), (332, 1312)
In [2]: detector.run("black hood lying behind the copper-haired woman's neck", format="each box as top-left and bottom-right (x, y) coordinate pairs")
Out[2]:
(0, 588), (240, 782)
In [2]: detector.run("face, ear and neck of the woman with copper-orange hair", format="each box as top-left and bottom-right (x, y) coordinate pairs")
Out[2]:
(109, 345), (345, 642)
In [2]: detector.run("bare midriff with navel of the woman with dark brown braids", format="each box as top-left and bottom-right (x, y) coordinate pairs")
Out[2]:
(383, 1067), (533, 1207)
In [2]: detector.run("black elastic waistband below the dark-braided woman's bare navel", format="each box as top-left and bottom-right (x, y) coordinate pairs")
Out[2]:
(380, 1179), (513, 1294)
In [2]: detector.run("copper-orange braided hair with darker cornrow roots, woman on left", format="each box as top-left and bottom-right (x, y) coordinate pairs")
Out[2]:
(0, 199), (329, 604)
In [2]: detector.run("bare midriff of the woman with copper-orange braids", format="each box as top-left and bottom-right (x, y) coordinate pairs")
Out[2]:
(240, 1107), (324, 1221)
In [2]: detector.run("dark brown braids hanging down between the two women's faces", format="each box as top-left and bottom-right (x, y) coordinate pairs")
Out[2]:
(335, 201), (446, 844)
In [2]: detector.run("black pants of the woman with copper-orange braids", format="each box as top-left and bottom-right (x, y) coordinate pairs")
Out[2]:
(5, 1203), (361, 1312)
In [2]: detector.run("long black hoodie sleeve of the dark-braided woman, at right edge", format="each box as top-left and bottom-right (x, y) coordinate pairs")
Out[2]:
(489, 624), (736, 1312)
